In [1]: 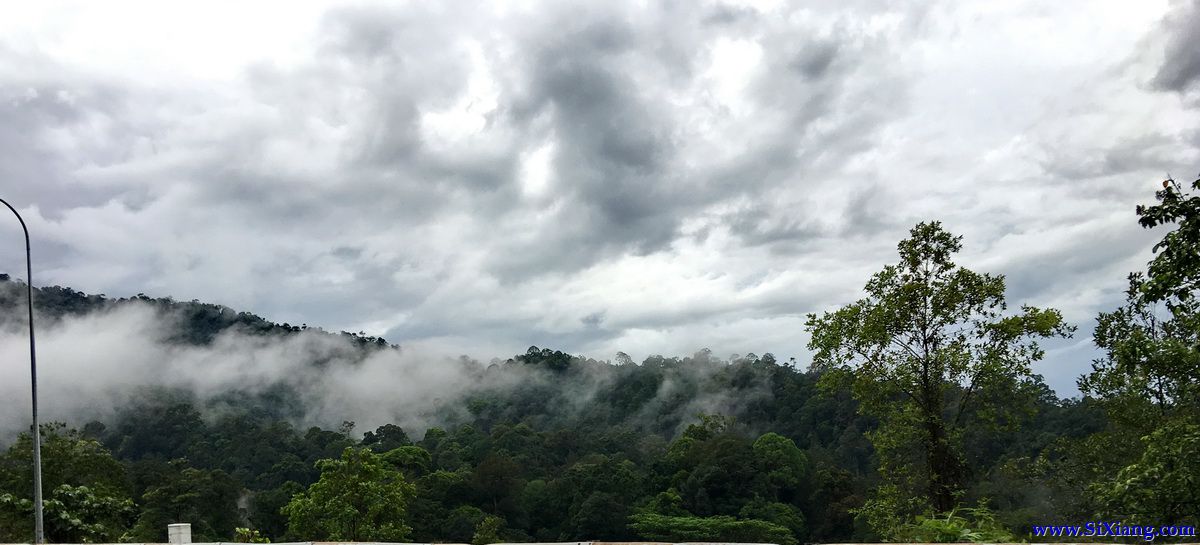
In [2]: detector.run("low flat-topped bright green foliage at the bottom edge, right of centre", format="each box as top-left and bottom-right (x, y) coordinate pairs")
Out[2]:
(629, 513), (799, 545)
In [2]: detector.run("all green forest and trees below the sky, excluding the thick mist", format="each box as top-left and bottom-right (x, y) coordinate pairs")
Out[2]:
(0, 181), (1200, 544)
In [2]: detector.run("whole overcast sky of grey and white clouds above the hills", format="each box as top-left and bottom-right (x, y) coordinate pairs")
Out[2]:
(0, 0), (1200, 394)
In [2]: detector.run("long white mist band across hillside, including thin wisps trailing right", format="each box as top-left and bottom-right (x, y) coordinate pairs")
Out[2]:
(0, 299), (769, 442)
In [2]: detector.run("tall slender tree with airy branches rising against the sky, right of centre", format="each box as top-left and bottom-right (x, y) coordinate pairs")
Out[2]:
(806, 222), (1072, 526)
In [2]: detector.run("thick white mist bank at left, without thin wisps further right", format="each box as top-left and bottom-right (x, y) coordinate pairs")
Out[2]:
(0, 301), (492, 437)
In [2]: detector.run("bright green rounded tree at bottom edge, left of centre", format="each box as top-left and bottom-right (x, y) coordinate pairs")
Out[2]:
(283, 448), (415, 541)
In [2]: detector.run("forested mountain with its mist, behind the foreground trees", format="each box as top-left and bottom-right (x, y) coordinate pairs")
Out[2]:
(0, 276), (1104, 541)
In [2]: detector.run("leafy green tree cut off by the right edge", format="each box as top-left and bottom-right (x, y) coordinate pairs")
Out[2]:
(1075, 180), (1200, 522)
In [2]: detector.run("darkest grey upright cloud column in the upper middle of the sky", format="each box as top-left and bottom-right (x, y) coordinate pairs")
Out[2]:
(487, 12), (694, 276)
